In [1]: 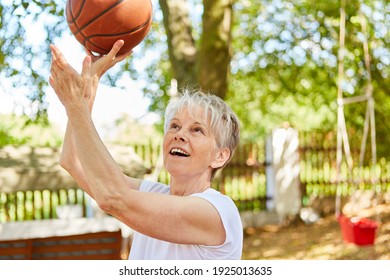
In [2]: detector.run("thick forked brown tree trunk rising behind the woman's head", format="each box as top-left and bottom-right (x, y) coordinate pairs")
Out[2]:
(159, 0), (233, 98)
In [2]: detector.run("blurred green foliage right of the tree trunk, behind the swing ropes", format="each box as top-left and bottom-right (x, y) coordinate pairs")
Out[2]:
(227, 0), (390, 151)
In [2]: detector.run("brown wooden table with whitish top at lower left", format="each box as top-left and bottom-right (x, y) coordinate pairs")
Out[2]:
(0, 217), (133, 259)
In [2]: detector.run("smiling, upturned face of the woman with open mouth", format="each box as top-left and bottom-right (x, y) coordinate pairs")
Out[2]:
(163, 108), (222, 180)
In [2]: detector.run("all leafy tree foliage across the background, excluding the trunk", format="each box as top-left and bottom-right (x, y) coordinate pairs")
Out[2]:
(0, 0), (390, 156)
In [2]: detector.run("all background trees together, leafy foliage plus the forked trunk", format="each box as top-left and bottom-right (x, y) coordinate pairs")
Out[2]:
(0, 0), (390, 158)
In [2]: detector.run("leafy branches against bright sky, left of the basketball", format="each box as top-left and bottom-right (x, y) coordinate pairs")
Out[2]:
(0, 0), (66, 118)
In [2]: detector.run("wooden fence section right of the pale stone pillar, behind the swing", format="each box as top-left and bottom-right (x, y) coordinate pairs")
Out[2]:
(300, 132), (390, 197)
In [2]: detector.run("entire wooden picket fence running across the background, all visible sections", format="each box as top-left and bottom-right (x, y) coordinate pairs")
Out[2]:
(0, 130), (390, 222)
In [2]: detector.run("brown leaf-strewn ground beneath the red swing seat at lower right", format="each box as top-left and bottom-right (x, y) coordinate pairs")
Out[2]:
(243, 204), (390, 260)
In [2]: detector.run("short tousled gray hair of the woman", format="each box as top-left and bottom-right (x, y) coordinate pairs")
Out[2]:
(164, 89), (240, 167)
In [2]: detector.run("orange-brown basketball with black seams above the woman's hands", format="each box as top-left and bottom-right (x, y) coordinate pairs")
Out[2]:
(65, 0), (153, 55)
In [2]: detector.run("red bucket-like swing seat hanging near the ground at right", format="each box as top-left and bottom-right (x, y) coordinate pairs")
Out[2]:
(338, 215), (378, 246)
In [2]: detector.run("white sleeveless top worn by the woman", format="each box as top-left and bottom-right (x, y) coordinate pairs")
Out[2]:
(129, 180), (243, 260)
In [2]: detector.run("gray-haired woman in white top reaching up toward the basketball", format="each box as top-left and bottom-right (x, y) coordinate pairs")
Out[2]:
(49, 40), (243, 260)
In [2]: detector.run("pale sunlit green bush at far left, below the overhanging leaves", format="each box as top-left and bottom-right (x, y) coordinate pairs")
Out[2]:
(0, 114), (63, 147)
